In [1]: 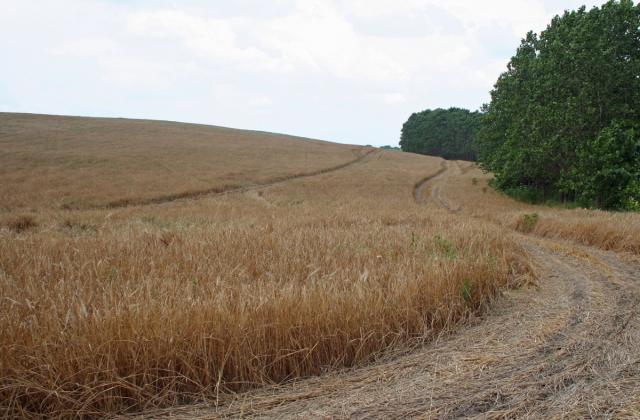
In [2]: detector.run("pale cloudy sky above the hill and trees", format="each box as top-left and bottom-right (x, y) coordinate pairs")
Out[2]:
(0, 0), (601, 146)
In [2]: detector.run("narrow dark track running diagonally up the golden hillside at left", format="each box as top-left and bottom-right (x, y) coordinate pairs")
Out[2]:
(87, 149), (379, 210)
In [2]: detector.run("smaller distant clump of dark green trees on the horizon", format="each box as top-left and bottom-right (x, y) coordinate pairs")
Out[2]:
(400, 108), (482, 160)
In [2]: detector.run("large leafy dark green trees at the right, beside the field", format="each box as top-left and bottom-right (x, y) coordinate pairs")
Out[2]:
(477, 0), (640, 209)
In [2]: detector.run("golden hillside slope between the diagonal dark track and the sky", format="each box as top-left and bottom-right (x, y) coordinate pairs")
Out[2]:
(0, 113), (364, 210)
